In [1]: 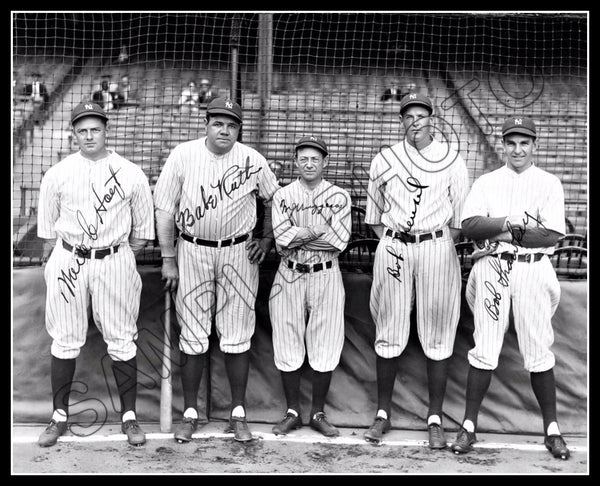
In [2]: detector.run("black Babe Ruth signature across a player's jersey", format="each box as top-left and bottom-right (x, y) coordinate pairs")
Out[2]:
(176, 157), (262, 227)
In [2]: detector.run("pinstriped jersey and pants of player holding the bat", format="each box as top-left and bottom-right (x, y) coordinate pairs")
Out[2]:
(154, 137), (279, 355)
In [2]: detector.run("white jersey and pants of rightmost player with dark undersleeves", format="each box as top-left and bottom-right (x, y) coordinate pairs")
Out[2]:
(462, 165), (565, 372)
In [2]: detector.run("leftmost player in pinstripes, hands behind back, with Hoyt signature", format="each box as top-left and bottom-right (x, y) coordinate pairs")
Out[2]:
(37, 102), (154, 446)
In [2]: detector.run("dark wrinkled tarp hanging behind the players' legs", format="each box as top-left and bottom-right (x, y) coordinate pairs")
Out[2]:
(12, 266), (588, 434)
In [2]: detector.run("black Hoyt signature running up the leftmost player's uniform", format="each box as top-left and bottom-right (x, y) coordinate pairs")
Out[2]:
(58, 165), (125, 304)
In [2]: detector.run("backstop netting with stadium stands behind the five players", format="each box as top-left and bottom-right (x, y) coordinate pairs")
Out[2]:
(12, 12), (588, 265)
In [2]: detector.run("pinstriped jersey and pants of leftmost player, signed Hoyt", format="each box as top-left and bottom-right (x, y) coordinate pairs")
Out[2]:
(37, 151), (154, 361)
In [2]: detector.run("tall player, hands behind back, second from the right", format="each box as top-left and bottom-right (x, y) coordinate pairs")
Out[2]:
(365, 93), (469, 449)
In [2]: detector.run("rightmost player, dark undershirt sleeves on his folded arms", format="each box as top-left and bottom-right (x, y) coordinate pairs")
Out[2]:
(452, 117), (570, 459)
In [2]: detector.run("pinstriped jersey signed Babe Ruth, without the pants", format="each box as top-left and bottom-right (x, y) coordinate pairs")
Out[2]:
(154, 137), (279, 240)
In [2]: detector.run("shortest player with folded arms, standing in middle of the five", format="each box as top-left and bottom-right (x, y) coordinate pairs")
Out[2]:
(269, 136), (352, 437)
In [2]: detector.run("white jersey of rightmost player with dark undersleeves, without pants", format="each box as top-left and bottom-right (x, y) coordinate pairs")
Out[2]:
(462, 165), (565, 255)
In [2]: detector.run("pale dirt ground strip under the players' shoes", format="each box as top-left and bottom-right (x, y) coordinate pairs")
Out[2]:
(12, 422), (589, 475)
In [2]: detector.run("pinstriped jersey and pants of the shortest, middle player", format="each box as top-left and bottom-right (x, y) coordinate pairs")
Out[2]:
(269, 179), (352, 372)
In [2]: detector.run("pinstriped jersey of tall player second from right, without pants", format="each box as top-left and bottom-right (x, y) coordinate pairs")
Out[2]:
(365, 140), (469, 233)
